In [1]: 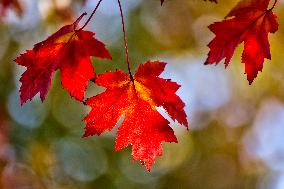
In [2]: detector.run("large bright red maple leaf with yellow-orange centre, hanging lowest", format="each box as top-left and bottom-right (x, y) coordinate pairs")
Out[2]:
(84, 61), (188, 170)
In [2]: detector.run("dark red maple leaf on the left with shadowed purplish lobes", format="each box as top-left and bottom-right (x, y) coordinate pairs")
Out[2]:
(15, 14), (111, 104)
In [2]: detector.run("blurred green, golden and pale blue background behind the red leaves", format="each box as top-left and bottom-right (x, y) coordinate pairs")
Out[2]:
(0, 0), (284, 189)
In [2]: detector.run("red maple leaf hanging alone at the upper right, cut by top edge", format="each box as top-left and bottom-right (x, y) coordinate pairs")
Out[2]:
(205, 0), (278, 84)
